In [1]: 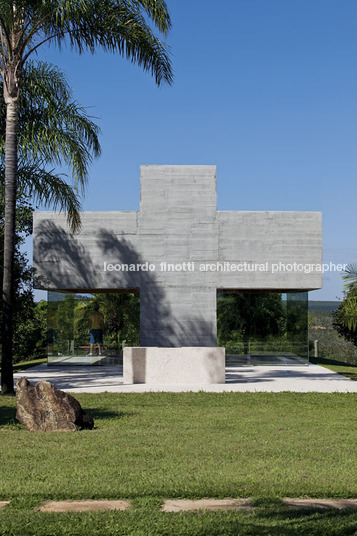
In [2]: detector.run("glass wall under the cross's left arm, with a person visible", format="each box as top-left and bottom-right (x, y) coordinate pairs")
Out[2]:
(47, 291), (140, 365)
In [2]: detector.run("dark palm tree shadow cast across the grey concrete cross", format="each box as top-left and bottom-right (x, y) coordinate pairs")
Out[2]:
(35, 219), (216, 347)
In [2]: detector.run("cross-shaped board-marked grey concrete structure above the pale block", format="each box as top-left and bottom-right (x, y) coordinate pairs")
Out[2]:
(34, 166), (322, 347)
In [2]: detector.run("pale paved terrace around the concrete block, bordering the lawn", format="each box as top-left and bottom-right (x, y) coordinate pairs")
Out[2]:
(11, 364), (357, 393)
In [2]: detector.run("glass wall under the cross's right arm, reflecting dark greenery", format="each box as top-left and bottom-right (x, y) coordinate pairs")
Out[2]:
(217, 290), (309, 365)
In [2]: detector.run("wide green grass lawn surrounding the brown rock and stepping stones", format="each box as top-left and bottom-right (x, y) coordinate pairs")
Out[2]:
(0, 393), (357, 536)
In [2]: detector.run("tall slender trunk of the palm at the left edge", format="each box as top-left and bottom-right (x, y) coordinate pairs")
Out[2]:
(1, 99), (18, 394)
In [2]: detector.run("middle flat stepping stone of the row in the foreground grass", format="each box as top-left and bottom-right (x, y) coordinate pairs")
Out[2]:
(161, 499), (254, 512)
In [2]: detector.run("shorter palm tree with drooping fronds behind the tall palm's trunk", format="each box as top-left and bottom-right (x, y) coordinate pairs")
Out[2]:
(0, 62), (100, 394)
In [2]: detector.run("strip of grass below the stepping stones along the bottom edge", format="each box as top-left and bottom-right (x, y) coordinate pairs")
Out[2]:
(0, 507), (357, 536)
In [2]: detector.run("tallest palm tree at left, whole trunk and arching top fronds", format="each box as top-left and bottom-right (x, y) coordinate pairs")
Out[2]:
(0, 0), (173, 394)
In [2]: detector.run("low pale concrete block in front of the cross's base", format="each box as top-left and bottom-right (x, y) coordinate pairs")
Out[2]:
(123, 347), (225, 385)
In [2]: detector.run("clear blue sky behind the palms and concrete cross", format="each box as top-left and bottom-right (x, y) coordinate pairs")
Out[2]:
(31, 0), (357, 299)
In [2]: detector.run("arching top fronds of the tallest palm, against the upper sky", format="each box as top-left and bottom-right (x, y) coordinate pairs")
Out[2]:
(18, 0), (173, 85)
